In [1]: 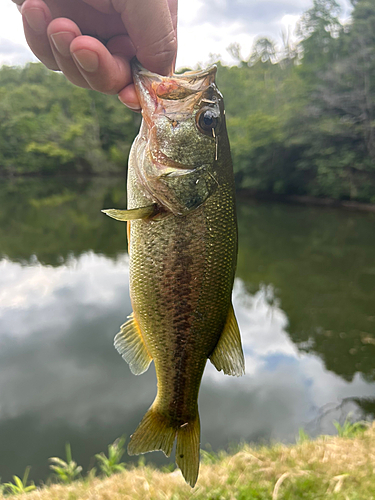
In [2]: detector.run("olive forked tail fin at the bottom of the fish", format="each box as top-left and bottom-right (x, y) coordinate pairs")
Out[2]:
(128, 404), (200, 488)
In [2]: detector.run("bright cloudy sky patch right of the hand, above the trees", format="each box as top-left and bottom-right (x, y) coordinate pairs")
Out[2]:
(177, 0), (351, 67)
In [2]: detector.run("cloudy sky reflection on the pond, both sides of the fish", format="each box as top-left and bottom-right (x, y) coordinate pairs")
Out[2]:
(0, 248), (375, 480)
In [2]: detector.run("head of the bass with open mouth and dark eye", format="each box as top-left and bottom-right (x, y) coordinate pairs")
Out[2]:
(133, 62), (229, 215)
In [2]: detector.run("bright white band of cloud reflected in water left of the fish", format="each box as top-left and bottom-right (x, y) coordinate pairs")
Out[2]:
(0, 252), (129, 341)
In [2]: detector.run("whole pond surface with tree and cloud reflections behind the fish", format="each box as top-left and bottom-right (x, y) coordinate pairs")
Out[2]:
(0, 179), (375, 481)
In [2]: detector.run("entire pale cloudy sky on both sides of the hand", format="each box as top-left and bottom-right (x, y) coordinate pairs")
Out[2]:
(0, 0), (350, 68)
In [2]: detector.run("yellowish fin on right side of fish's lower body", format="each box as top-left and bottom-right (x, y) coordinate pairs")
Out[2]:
(210, 304), (245, 377)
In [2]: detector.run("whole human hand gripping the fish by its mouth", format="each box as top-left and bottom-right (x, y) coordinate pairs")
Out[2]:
(12, 0), (177, 110)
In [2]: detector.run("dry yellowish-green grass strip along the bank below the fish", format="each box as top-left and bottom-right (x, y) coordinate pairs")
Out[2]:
(0, 424), (375, 500)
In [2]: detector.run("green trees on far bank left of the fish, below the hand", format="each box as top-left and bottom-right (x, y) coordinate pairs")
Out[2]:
(0, 64), (138, 175)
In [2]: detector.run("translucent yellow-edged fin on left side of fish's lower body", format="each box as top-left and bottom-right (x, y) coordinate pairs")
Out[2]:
(114, 313), (152, 375)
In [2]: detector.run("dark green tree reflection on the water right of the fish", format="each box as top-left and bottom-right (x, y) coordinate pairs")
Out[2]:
(238, 203), (375, 381)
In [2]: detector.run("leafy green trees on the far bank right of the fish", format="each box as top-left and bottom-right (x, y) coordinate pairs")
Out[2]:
(218, 0), (375, 202)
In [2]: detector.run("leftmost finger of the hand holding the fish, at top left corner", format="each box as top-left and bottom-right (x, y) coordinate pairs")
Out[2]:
(21, 0), (59, 70)
